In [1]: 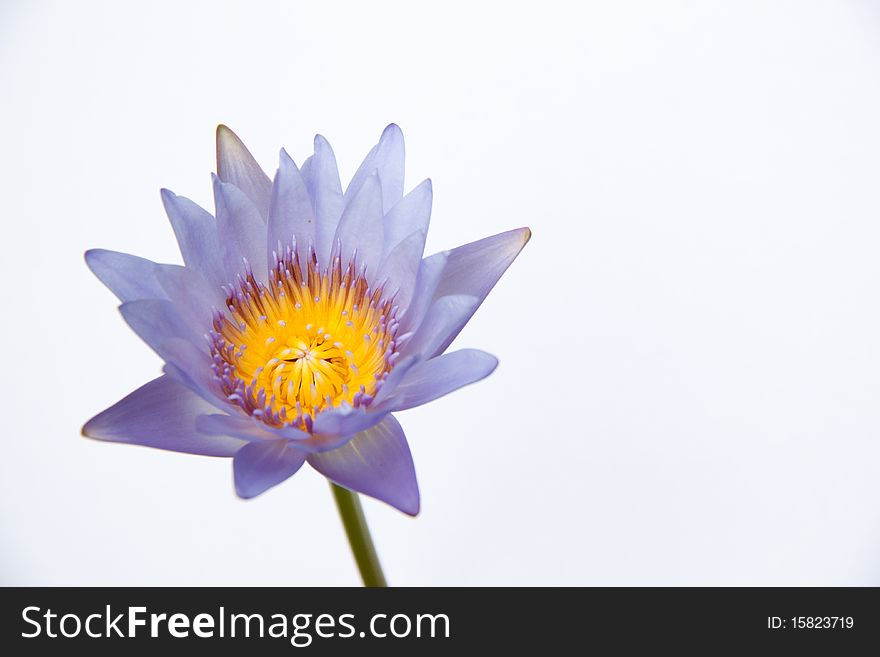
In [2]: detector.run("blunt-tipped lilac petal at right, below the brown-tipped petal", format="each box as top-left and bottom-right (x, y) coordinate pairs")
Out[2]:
(385, 349), (498, 411)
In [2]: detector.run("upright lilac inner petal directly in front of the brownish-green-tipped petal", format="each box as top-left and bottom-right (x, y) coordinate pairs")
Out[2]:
(214, 176), (268, 282)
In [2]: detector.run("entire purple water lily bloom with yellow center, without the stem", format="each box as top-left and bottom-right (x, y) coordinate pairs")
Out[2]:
(83, 125), (530, 515)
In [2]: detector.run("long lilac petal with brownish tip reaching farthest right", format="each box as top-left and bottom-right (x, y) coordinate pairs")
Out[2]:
(420, 228), (532, 354)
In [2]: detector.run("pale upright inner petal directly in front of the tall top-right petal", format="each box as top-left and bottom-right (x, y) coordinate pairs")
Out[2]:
(333, 174), (383, 275)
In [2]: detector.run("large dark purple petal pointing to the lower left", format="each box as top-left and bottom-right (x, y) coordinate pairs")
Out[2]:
(83, 376), (246, 456)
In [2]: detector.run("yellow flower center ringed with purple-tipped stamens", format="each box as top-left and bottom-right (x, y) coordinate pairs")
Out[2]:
(209, 248), (397, 431)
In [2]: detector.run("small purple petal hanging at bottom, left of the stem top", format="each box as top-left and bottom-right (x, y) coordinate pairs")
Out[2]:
(232, 440), (306, 499)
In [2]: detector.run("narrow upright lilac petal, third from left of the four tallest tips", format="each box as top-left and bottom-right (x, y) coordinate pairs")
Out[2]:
(300, 135), (343, 267)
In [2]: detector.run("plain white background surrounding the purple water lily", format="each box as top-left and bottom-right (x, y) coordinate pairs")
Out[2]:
(0, 0), (880, 585)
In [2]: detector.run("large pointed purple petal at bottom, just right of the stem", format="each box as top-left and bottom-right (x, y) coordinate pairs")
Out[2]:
(308, 415), (419, 516)
